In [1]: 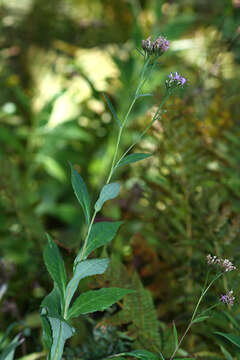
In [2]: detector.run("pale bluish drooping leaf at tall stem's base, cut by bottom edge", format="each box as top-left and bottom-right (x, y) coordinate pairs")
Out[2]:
(48, 316), (75, 360)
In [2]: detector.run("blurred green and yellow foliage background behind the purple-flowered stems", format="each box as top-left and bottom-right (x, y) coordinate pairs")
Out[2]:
(0, 0), (240, 360)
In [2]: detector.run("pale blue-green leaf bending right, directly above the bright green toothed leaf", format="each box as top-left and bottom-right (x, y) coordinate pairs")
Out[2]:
(65, 259), (109, 309)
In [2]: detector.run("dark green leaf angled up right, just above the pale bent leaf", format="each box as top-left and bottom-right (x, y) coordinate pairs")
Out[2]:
(74, 221), (122, 264)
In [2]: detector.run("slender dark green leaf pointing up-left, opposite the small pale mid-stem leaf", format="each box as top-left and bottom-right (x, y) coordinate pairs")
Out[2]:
(69, 163), (91, 225)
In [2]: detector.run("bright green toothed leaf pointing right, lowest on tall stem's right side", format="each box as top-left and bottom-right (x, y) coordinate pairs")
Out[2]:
(68, 287), (134, 318)
